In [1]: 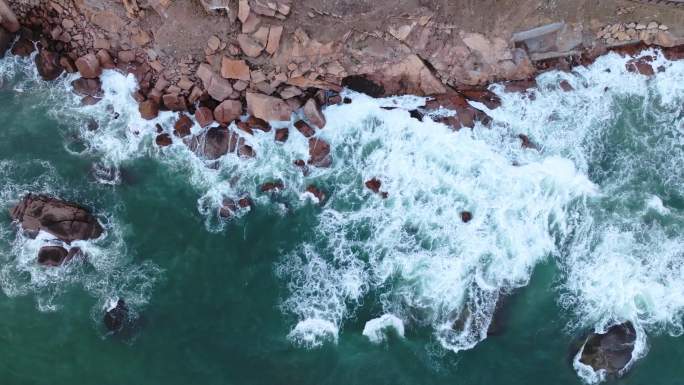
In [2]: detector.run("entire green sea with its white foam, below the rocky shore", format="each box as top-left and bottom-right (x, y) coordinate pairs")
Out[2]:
(0, 51), (684, 385)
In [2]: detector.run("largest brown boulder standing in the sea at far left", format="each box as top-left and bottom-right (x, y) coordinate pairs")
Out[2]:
(10, 194), (103, 242)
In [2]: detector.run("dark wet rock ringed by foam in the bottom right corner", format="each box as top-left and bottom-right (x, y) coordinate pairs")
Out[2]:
(580, 322), (636, 376)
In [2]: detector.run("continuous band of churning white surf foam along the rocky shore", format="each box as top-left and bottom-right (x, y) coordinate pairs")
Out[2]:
(2, 45), (684, 380)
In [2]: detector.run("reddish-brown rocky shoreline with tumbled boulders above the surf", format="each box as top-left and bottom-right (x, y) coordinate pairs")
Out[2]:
(0, 0), (684, 140)
